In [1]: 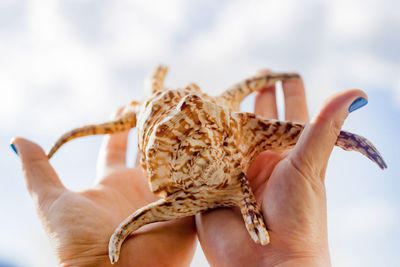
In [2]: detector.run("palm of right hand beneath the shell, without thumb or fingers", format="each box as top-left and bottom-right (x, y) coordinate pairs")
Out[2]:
(197, 151), (327, 266)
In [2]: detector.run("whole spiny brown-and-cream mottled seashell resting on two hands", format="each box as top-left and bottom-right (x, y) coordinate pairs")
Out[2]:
(43, 67), (386, 263)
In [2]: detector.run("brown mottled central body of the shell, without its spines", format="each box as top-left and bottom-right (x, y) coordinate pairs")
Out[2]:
(145, 94), (235, 195)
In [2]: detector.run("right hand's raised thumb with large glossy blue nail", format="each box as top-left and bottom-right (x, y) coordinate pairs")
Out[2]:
(289, 89), (367, 179)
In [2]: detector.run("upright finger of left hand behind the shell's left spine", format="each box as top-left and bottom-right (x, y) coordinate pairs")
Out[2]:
(97, 108), (129, 173)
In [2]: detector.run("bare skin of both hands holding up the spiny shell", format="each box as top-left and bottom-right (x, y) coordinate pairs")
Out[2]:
(12, 71), (367, 266)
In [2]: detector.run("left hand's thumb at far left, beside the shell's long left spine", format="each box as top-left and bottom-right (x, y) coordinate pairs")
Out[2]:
(11, 138), (66, 204)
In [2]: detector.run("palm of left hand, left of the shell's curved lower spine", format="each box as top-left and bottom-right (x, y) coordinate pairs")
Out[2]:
(40, 168), (155, 264)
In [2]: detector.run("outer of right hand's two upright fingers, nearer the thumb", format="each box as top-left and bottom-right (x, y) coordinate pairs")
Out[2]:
(282, 75), (309, 122)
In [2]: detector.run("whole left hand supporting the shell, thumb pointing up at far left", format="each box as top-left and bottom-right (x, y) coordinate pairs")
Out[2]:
(12, 109), (196, 266)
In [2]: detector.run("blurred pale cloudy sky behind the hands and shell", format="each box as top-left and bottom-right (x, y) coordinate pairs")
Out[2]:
(0, 0), (400, 267)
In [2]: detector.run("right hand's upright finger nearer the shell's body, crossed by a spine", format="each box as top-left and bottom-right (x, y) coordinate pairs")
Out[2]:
(254, 70), (278, 119)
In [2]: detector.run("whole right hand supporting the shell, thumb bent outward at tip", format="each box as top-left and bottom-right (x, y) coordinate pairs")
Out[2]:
(196, 70), (366, 266)
